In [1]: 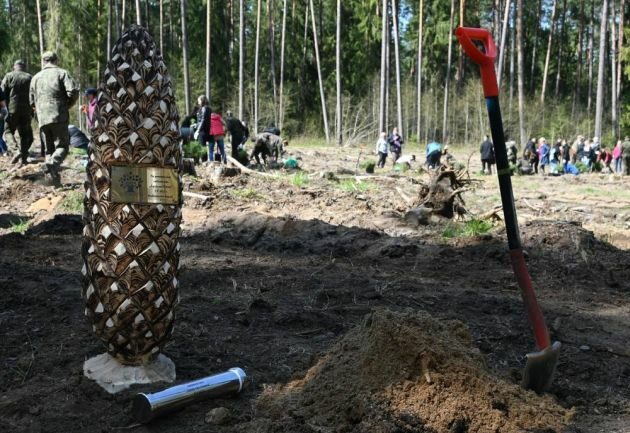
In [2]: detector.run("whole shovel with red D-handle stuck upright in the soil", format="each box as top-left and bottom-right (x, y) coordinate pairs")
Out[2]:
(455, 27), (560, 393)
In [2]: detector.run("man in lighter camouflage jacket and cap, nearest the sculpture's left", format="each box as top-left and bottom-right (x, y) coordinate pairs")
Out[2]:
(30, 51), (79, 185)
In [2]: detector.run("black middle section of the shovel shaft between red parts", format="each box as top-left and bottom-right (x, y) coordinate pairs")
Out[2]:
(486, 96), (521, 250)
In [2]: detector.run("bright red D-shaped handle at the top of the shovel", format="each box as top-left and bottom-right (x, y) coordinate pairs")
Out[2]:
(455, 27), (499, 98)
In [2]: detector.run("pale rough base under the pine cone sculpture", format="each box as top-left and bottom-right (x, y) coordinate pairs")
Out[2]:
(83, 353), (175, 394)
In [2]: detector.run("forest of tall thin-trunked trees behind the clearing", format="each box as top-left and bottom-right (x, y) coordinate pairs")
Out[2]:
(0, 0), (630, 148)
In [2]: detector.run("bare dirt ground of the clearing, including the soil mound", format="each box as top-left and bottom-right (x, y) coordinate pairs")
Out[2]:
(0, 143), (630, 433)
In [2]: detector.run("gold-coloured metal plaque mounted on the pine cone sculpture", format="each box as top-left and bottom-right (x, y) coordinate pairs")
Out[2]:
(110, 165), (179, 204)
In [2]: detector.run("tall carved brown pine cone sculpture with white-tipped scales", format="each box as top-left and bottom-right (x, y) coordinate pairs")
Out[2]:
(82, 26), (182, 365)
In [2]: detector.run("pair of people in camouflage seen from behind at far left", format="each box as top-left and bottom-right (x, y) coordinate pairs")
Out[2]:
(0, 51), (79, 184)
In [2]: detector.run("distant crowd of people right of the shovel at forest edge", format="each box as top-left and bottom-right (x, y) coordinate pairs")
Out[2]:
(520, 135), (630, 175)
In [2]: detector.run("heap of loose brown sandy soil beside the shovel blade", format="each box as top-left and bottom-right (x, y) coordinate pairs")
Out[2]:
(253, 309), (571, 433)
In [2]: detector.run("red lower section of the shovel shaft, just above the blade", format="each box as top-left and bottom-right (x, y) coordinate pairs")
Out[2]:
(510, 248), (551, 350)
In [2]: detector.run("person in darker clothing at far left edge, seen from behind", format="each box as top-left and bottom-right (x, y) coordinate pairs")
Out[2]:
(0, 60), (33, 164)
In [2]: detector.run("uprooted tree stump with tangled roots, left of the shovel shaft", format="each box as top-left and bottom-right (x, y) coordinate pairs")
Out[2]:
(414, 165), (479, 218)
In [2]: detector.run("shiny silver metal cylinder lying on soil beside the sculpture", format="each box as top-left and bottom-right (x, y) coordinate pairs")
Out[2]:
(131, 367), (247, 423)
